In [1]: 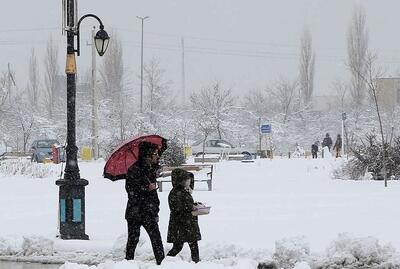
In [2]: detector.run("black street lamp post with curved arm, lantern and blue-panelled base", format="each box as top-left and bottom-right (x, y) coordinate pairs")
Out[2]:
(56, 0), (110, 240)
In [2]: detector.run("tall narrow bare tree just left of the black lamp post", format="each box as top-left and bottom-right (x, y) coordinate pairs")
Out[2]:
(44, 37), (60, 119)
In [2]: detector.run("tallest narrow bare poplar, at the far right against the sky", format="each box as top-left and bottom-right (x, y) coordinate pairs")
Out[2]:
(347, 6), (368, 108)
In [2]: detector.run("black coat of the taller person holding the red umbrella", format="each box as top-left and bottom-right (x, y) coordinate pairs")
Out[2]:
(125, 161), (160, 220)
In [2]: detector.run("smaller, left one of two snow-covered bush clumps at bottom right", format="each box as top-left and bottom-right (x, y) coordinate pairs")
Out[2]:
(273, 237), (310, 269)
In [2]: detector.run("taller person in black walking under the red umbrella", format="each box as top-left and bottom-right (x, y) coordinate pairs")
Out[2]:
(125, 142), (164, 265)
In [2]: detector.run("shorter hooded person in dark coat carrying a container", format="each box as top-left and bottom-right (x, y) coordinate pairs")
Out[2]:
(167, 168), (201, 263)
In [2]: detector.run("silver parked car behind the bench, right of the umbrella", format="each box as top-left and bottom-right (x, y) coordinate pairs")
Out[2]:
(192, 139), (253, 157)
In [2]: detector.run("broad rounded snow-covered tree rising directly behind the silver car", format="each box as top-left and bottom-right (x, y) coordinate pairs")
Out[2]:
(190, 82), (235, 138)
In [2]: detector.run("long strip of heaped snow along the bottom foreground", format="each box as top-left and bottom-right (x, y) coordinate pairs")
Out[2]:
(0, 233), (400, 269)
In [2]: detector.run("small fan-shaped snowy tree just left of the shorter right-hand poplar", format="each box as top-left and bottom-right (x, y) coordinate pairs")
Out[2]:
(269, 78), (298, 123)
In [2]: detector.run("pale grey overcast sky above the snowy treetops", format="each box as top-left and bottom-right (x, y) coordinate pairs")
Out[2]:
(0, 0), (400, 95)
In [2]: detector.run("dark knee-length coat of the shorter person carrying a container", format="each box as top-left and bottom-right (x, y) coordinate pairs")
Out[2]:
(167, 185), (201, 243)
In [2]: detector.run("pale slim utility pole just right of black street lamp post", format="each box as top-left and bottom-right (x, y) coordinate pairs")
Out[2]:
(90, 27), (99, 160)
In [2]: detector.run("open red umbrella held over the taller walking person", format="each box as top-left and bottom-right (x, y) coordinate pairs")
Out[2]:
(103, 135), (167, 181)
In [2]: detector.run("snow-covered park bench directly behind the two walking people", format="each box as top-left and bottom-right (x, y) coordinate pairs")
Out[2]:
(157, 164), (214, 192)
